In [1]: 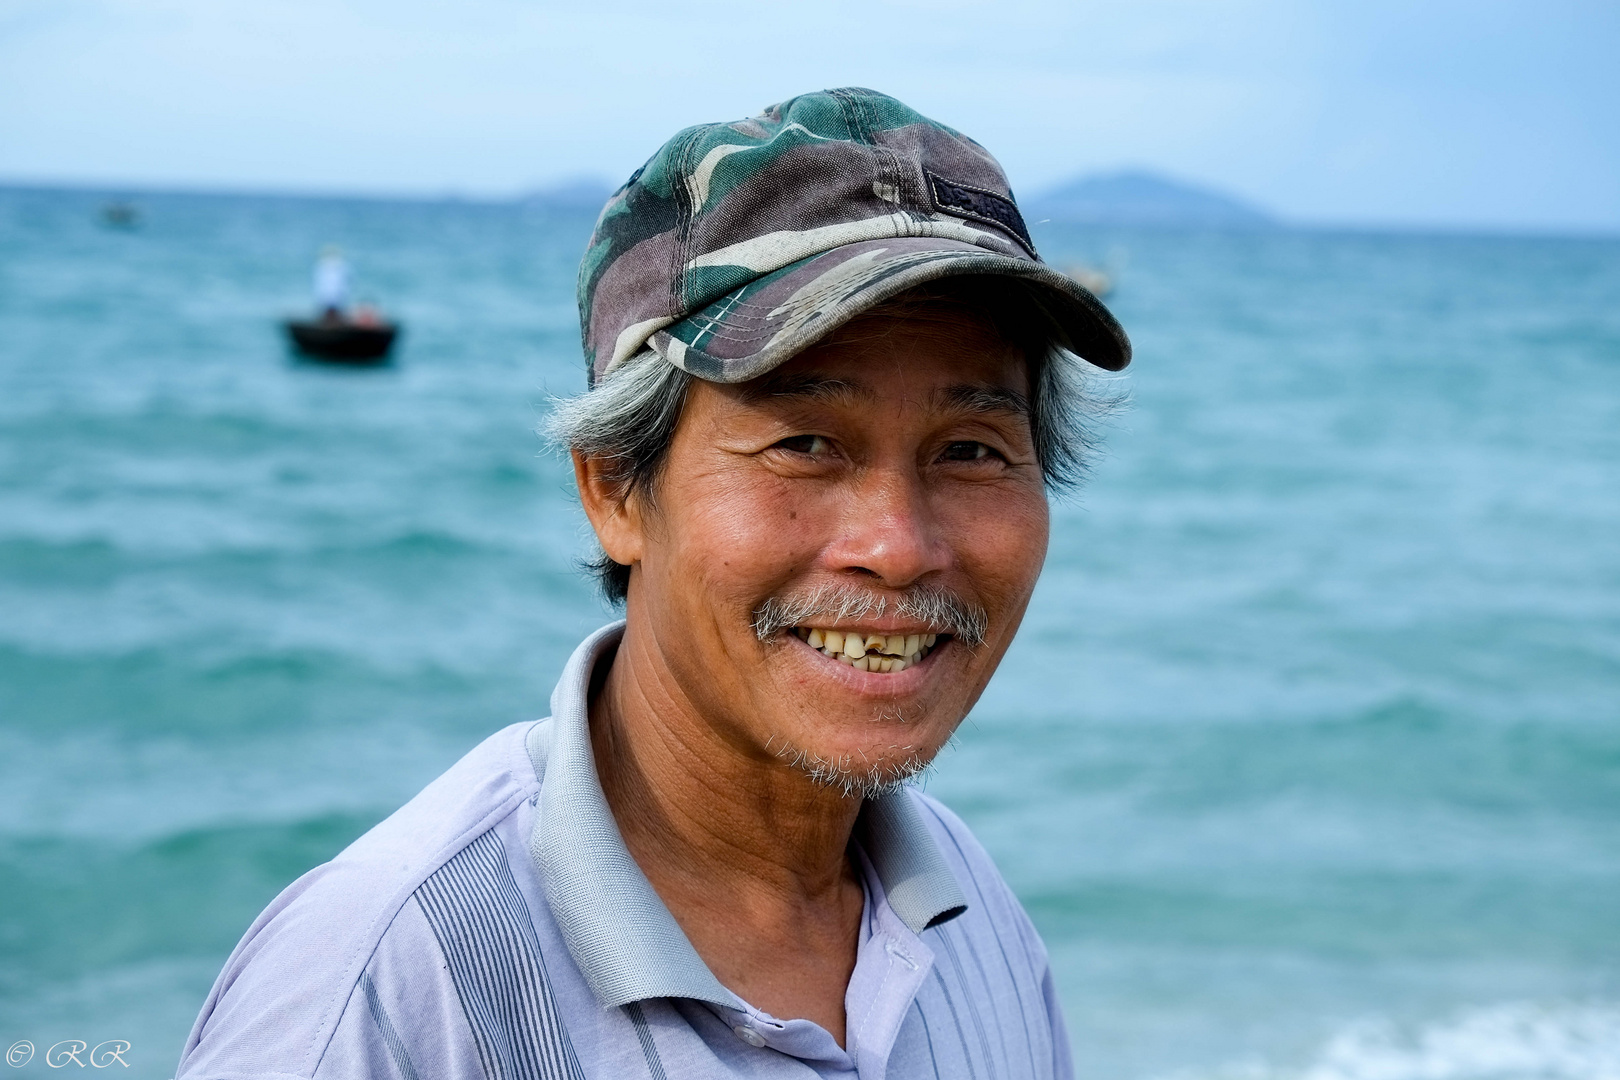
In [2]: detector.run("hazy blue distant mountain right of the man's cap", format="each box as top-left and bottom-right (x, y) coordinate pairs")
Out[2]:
(1024, 172), (1277, 228)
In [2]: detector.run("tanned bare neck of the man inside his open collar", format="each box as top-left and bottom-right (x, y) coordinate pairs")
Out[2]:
(590, 631), (862, 1043)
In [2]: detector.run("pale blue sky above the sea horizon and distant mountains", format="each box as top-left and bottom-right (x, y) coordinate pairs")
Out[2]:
(0, 0), (1620, 232)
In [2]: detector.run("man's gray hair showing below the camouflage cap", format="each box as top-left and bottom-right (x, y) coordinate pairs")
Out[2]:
(543, 277), (1126, 604)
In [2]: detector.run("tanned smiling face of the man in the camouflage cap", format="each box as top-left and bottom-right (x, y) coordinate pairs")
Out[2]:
(609, 307), (1048, 782)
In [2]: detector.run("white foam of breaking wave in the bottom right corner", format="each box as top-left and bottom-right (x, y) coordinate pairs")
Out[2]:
(1175, 1002), (1620, 1080)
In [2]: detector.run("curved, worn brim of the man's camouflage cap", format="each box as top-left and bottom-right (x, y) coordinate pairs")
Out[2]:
(650, 236), (1131, 382)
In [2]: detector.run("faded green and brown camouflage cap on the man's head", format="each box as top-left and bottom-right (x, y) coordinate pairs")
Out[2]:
(578, 89), (1131, 385)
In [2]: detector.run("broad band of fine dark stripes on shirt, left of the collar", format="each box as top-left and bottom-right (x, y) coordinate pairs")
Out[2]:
(416, 832), (583, 1080)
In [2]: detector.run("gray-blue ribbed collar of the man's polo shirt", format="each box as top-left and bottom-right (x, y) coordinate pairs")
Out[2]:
(528, 622), (967, 1009)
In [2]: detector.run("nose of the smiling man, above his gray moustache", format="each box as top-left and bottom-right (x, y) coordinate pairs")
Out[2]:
(826, 468), (953, 588)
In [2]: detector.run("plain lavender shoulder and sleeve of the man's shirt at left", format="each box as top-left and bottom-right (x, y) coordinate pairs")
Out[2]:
(180, 722), (539, 1077)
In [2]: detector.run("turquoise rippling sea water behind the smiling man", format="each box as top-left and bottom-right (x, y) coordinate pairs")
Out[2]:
(0, 189), (1620, 1080)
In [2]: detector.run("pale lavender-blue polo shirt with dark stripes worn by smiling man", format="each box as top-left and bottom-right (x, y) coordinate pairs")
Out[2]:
(178, 623), (1072, 1080)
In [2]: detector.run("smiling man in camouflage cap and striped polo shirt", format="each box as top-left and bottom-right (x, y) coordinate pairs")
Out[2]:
(180, 89), (1129, 1080)
